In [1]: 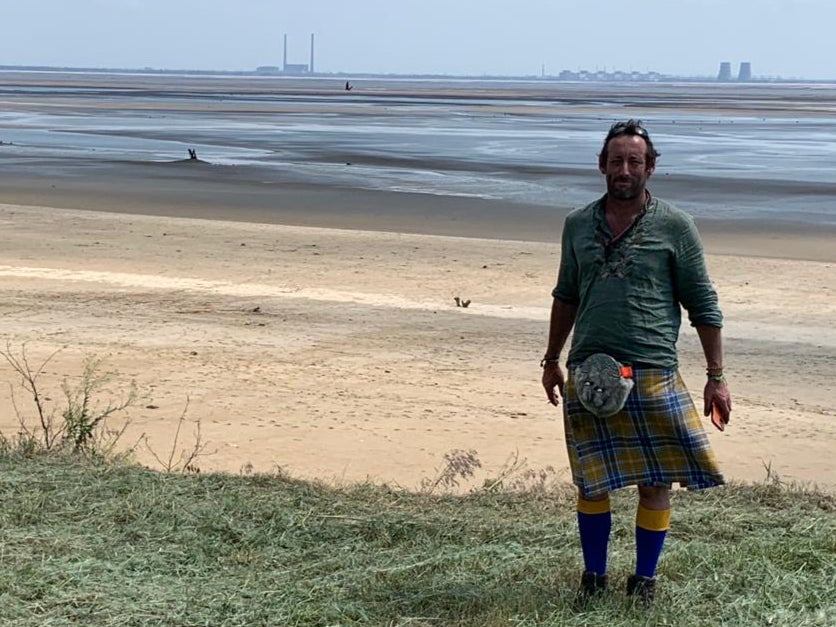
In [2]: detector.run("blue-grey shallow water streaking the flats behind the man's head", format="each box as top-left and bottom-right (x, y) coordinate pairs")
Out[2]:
(0, 77), (836, 224)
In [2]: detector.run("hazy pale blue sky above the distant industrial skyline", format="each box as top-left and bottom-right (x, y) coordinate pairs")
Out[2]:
(0, 0), (836, 79)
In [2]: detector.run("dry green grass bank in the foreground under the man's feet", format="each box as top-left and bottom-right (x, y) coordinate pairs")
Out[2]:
(0, 447), (836, 627)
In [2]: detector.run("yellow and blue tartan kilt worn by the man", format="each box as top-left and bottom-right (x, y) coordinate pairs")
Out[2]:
(563, 364), (725, 496)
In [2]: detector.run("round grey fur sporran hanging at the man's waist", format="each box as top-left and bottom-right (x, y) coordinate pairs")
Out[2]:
(574, 353), (634, 418)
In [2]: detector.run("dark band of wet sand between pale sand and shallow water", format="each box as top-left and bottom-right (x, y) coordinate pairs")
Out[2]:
(0, 161), (836, 261)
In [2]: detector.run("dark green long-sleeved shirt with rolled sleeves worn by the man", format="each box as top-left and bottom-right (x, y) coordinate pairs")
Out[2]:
(552, 196), (723, 368)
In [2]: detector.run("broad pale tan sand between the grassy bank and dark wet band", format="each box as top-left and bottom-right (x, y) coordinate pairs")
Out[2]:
(0, 178), (836, 490)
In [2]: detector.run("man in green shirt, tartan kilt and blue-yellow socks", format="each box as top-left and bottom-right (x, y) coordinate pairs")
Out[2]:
(542, 120), (731, 604)
